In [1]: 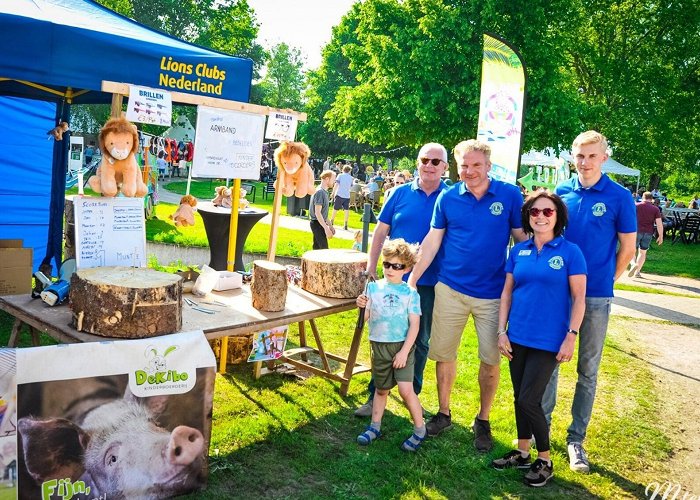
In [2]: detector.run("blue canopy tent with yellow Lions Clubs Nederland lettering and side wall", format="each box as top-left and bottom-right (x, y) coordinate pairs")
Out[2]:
(0, 0), (253, 269)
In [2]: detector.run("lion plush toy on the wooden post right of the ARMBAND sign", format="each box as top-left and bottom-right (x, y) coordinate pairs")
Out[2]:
(275, 142), (314, 198)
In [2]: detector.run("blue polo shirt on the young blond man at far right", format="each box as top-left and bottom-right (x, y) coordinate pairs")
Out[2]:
(555, 174), (637, 297)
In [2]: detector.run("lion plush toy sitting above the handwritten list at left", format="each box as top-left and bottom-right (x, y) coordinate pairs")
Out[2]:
(88, 118), (148, 198)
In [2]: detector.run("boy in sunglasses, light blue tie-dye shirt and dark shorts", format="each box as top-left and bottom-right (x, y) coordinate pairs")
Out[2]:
(357, 238), (427, 452)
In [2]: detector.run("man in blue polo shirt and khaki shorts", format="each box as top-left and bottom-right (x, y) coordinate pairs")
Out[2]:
(408, 140), (526, 451)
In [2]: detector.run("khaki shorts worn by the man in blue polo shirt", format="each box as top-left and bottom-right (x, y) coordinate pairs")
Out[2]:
(428, 282), (501, 365)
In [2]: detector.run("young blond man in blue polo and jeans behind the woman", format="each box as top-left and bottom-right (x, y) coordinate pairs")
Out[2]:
(542, 130), (637, 472)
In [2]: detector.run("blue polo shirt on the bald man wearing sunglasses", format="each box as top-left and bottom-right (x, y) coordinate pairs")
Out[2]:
(379, 178), (447, 286)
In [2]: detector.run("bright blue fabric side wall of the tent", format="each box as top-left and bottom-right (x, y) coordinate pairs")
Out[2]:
(0, 97), (56, 270)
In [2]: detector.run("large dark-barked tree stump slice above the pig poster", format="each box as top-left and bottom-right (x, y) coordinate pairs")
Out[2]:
(69, 266), (182, 338)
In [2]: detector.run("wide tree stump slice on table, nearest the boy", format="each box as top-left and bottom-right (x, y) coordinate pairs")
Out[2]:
(301, 249), (367, 299)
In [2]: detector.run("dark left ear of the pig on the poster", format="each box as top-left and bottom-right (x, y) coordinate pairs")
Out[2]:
(17, 417), (90, 483)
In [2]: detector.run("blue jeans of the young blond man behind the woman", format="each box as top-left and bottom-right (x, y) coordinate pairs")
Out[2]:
(542, 297), (612, 443)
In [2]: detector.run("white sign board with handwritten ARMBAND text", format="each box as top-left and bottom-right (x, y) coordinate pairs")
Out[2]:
(192, 106), (265, 179)
